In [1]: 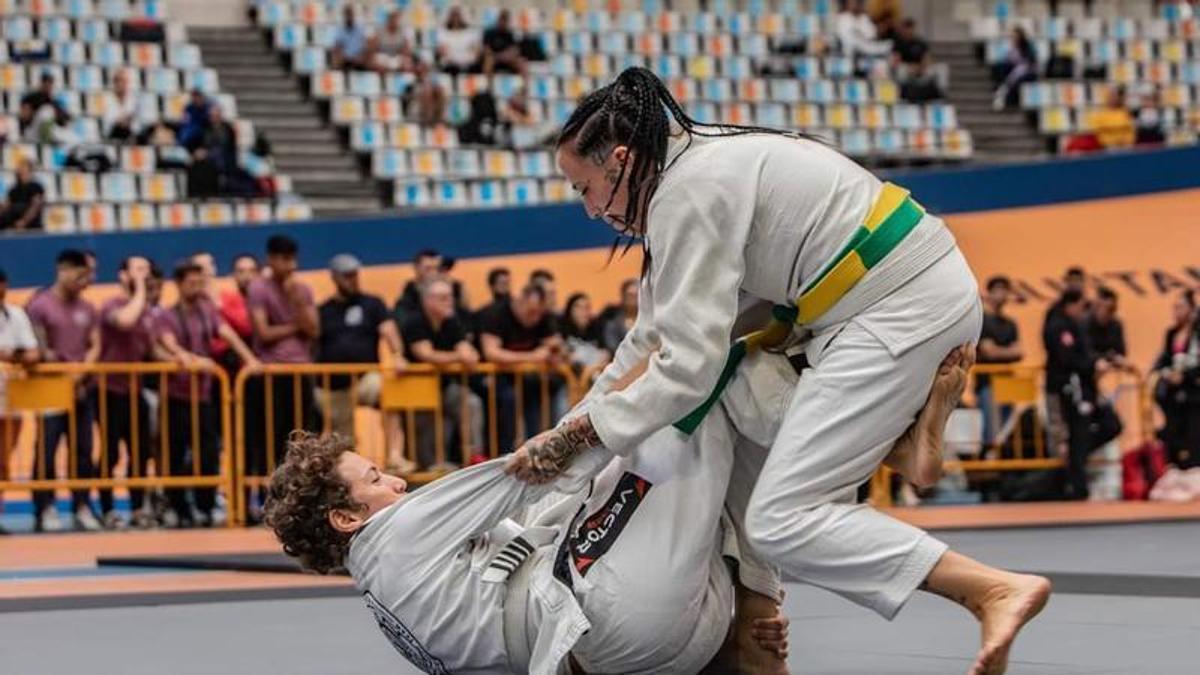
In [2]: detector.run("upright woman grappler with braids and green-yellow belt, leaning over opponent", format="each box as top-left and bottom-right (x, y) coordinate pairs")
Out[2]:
(509, 68), (1050, 673)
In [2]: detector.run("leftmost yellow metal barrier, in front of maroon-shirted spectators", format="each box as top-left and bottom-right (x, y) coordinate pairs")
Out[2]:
(0, 363), (234, 525)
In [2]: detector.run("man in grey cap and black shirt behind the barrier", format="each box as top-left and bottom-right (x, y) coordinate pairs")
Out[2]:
(316, 253), (416, 473)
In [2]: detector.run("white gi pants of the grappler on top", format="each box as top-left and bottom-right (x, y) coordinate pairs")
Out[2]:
(745, 249), (982, 619)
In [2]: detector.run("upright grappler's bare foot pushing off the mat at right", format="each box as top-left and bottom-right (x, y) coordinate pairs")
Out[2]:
(968, 574), (1050, 675)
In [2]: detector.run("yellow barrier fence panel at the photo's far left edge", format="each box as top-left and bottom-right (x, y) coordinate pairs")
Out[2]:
(0, 363), (234, 525)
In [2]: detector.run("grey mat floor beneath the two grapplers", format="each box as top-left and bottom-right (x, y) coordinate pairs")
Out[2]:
(0, 511), (1200, 675)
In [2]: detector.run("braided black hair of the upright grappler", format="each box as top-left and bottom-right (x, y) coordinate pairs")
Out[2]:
(557, 67), (811, 234)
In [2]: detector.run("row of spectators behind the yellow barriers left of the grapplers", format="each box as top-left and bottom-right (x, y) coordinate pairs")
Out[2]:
(0, 235), (637, 531)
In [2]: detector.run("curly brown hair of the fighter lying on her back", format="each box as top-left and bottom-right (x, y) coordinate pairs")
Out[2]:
(264, 430), (362, 574)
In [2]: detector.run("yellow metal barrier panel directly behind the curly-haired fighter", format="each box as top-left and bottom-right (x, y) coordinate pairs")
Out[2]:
(234, 363), (581, 521)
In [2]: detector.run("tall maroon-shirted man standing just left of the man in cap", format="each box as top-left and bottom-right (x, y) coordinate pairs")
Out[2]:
(246, 234), (320, 520)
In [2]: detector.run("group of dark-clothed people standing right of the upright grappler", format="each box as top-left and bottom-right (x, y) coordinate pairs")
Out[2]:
(976, 267), (1200, 500)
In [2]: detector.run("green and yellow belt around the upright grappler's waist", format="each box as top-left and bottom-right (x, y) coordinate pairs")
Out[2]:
(674, 183), (925, 434)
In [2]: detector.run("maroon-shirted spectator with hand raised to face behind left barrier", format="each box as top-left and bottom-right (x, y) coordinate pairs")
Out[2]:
(97, 256), (162, 530)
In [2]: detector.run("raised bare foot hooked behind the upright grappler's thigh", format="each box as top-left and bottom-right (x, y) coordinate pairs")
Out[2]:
(883, 342), (976, 489)
